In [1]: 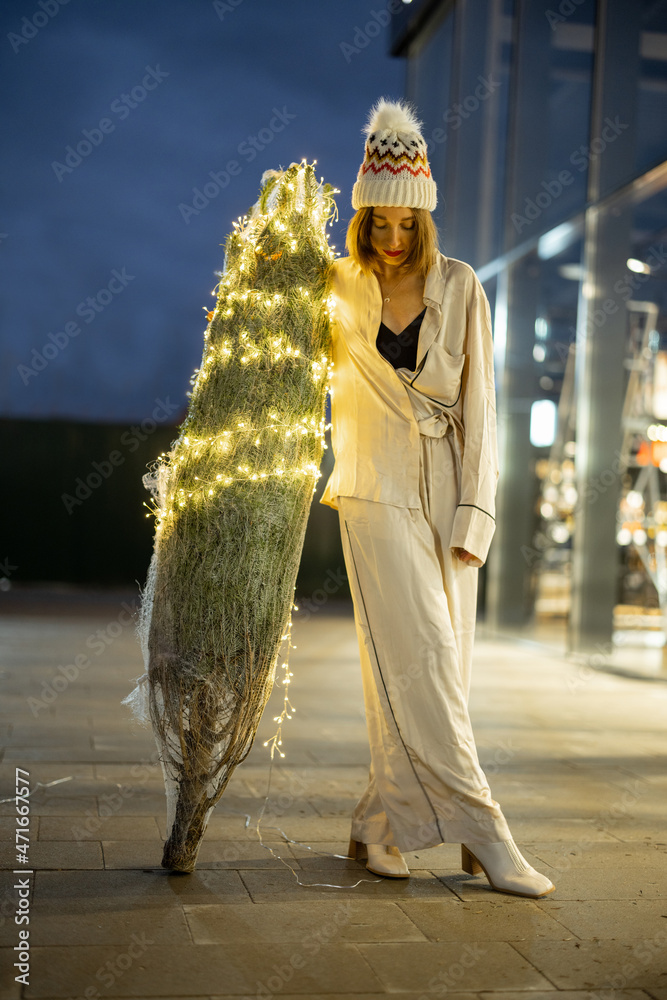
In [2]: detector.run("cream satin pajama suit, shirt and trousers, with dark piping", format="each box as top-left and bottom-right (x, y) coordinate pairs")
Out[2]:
(320, 254), (511, 851)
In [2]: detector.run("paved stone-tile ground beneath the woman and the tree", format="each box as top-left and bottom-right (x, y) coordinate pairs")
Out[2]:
(0, 595), (667, 1000)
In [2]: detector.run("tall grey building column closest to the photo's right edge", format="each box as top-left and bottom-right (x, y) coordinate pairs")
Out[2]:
(568, 0), (643, 653)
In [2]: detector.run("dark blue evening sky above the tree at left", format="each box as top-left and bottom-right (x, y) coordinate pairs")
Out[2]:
(0, 0), (405, 423)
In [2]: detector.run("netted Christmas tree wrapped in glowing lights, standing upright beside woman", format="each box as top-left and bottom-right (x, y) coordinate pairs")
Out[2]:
(124, 162), (335, 871)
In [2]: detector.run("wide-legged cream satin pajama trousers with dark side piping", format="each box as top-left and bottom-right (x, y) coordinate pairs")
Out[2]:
(338, 435), (511, 851)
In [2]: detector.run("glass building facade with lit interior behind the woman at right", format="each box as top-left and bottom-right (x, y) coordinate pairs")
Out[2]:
(392, 0), (667, 671)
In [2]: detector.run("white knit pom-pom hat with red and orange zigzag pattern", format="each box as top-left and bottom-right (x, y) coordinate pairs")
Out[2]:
(352, 97), (438, 212)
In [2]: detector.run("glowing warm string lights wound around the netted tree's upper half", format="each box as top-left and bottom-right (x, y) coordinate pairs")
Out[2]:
(147, 161), (335, 548)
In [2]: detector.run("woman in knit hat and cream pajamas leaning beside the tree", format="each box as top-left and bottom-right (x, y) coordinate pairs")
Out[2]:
(320, 100), (554, 898)
